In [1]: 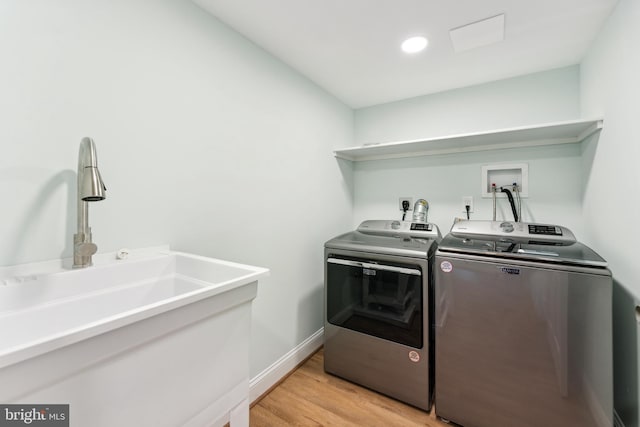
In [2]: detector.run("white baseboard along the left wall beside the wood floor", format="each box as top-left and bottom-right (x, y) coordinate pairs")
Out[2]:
(249, 328), (324, 403)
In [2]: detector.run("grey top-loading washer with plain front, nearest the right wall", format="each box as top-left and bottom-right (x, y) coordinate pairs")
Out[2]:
(435, 221), (613, 427)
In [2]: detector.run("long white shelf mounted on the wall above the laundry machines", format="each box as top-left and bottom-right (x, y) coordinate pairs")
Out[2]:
(333, 119), (603, 162)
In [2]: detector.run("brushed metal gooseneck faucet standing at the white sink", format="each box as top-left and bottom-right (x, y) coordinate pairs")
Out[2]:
(73, 137), (107, 268)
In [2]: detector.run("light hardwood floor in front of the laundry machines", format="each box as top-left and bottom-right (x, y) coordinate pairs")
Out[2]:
(250, 349), (450, 427)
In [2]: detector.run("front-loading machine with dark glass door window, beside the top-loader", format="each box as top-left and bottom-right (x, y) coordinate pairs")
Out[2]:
(324, 220), (442, 411)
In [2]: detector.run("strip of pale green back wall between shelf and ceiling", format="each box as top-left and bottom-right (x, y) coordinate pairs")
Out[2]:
(355, 66), (580, 144)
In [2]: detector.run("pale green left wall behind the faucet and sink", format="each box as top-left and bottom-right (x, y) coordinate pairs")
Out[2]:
(0, 0), (353, 382)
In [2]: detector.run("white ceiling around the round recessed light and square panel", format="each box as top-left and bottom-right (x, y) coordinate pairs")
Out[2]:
(193, 0), (617, 108)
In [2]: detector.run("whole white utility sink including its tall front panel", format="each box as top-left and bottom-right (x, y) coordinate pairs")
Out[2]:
(0, 249), (268, 425)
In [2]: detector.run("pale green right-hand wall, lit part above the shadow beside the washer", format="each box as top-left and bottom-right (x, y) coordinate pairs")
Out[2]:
(581, 0), (640, 295)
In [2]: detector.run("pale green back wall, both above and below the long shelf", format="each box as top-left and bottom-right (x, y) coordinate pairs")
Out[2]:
(354, 66), (583, 236)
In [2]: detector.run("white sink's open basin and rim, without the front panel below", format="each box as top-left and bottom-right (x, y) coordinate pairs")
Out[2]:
(0, 249), (268, 368)
